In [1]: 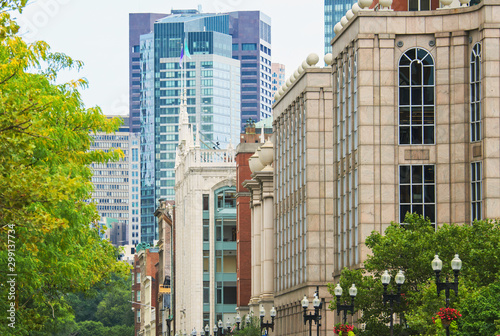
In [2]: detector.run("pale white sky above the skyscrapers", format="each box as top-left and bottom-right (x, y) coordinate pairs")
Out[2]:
(15, 0), (324, 115)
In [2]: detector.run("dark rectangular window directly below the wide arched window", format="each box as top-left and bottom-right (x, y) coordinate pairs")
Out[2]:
(399, 165), (436, 224)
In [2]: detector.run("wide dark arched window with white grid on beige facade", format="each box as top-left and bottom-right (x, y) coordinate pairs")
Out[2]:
(399, 48), (434, 145)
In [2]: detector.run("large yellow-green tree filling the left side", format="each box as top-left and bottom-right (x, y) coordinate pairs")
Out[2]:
(0, 0), (129, 335)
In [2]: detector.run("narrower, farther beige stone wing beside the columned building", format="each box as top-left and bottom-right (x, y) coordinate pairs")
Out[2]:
(274, 68), (334, 336)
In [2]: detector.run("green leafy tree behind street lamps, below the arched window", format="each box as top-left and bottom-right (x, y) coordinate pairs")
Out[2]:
(329, 215), (500, 335)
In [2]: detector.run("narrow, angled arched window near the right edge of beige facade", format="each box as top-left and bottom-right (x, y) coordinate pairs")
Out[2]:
(470, 43), (481, 142)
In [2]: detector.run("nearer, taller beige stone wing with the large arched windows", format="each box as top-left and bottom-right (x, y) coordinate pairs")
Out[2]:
(332, 1), (500, 275)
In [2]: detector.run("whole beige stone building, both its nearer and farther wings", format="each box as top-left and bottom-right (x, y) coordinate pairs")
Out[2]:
(270, 0), (500, 335)
